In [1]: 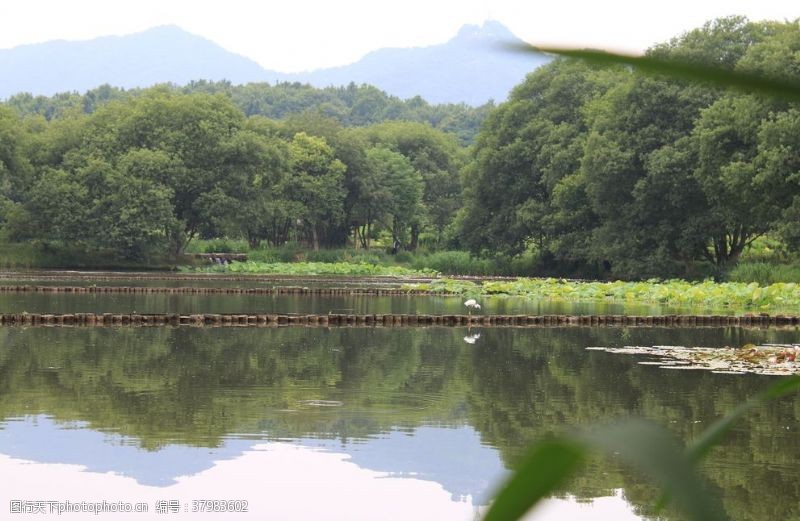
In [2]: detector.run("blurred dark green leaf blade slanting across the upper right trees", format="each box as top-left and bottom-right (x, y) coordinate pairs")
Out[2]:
(504, 43), (800, 101)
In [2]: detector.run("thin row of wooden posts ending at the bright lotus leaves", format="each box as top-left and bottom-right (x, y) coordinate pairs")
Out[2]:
(0, 286), (444, 296)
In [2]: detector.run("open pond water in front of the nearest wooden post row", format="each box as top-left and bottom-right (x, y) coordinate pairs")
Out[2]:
(0, 322), (800, 520)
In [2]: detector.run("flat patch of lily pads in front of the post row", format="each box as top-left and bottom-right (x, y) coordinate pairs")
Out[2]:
(586, 344), (800, 375)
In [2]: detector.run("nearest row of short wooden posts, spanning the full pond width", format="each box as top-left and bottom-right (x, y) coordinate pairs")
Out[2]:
(0, 313), (800, 327)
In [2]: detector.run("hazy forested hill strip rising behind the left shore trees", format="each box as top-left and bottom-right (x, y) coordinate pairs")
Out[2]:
(4, 80), (494, 144)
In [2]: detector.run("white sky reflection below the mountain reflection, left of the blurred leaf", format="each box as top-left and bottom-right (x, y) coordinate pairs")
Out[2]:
(0, 443), (474, 521)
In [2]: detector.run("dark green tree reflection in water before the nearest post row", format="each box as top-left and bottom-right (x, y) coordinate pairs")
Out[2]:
(0, 328), (800, 520)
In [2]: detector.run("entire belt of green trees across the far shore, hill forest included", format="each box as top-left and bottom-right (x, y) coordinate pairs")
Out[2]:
(0, 17), (800, 280)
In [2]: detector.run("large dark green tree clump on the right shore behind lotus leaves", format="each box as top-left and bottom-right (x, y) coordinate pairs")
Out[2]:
(459, 17), (800, 278)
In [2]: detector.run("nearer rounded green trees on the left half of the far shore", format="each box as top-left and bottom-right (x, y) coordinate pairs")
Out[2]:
(0, 91), (462, 260)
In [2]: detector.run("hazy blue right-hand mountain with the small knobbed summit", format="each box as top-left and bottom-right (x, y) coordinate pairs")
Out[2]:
(294, 21), (549, 105)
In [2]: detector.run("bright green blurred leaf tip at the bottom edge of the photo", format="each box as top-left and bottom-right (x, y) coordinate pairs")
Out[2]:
(484, 438), (587, 521)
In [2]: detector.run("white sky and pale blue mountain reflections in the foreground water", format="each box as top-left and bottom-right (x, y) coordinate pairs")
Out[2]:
(0, 417), (639, 521)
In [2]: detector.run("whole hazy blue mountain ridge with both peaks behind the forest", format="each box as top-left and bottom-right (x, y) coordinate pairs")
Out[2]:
(0, 21), (548, 105)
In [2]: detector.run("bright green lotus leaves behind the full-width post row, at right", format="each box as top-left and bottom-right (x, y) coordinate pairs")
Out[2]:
(405, 278), (800, 313)
